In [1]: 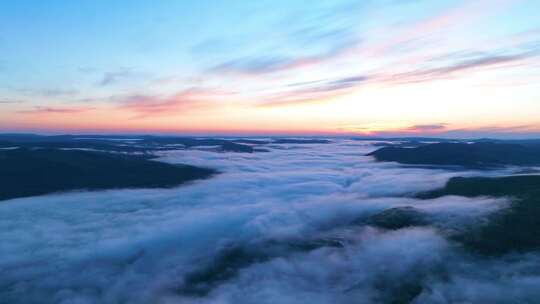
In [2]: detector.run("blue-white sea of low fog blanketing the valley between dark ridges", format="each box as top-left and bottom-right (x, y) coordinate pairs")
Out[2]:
(0, 140), (540, 304)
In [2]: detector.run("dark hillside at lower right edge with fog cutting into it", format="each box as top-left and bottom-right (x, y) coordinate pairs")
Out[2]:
(418, 175), (540, 255)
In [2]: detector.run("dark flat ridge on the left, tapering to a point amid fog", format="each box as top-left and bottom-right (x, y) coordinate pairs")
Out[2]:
(0, 149), (216, 200)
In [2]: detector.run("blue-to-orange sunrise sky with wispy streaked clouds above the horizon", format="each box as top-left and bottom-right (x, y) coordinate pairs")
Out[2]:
(0, 0), (540, 138)
